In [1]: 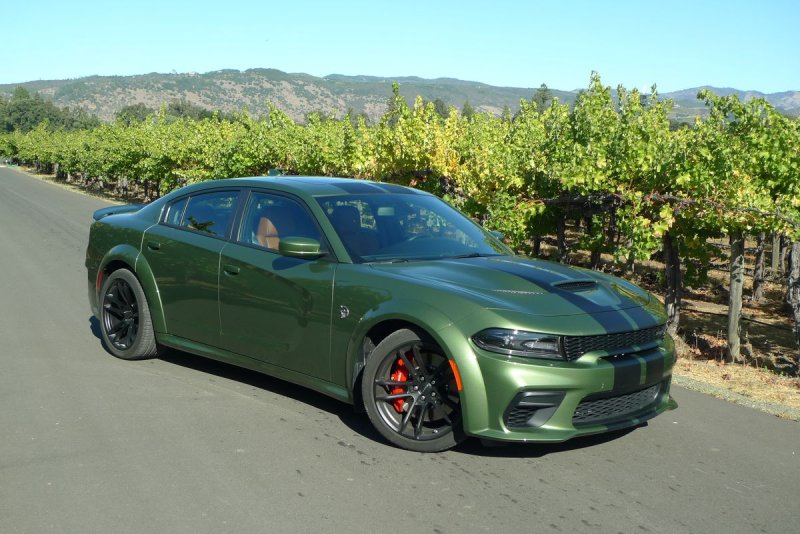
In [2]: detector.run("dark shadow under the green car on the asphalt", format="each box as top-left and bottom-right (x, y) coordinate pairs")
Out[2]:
(89, 317), (647, 458)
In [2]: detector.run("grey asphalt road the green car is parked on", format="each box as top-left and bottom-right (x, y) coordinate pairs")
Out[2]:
(0, 168), (800, 533)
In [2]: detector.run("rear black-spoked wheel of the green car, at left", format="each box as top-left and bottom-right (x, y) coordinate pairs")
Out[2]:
(100, 269), (158, 360)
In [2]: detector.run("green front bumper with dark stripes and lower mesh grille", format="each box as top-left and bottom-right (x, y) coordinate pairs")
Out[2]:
(438, 328), (677, 442)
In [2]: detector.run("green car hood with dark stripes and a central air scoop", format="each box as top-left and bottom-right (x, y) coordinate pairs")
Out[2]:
(371, 256), (651, 317)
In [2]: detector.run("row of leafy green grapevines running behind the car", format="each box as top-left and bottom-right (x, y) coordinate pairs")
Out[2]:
(0, 73), (800, 368)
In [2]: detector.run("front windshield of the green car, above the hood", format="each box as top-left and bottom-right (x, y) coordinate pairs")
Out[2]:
(317, 194), (511, 263)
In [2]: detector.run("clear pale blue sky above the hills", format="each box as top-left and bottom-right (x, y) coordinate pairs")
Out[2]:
(6, 0), (800, 92)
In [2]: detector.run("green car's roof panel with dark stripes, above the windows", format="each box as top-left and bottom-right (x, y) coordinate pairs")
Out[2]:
(189, 176), (427, 197)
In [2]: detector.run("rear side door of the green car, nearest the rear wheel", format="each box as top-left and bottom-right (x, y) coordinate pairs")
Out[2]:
(142, 189), (240, 346)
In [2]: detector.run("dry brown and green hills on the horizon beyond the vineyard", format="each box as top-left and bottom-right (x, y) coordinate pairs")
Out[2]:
(0, 69), (800, 120)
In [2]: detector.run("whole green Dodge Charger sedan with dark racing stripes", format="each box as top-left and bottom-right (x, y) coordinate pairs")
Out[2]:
(86, 177), (675, 452)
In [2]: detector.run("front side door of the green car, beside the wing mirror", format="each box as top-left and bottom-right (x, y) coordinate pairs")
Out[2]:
(219, 191), (336, 380)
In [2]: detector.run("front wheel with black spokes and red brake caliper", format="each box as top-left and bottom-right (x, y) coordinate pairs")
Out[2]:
(361, 329), (465, 452)
